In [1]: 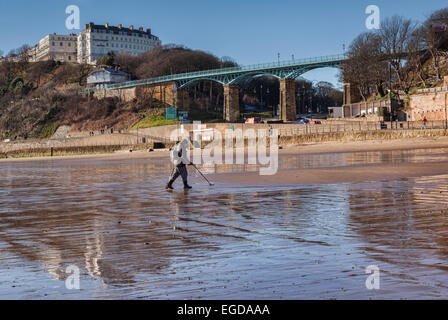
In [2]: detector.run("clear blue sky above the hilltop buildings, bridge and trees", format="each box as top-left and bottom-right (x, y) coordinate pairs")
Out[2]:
(0, 0), (448, 84)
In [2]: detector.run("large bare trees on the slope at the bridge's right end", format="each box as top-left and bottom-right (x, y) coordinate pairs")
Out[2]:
(341, 8), (448, 99)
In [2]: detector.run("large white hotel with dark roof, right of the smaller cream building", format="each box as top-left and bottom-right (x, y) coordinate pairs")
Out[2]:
(77, 22), (161, 64)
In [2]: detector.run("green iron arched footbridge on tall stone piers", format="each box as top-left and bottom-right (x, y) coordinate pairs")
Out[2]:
(85, 54), (347, 121)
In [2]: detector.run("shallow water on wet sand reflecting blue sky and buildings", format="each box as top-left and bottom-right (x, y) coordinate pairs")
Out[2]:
(0, 149), (448, 299)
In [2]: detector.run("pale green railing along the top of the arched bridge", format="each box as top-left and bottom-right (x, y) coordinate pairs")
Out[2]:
(81, 54), (347, 93)
